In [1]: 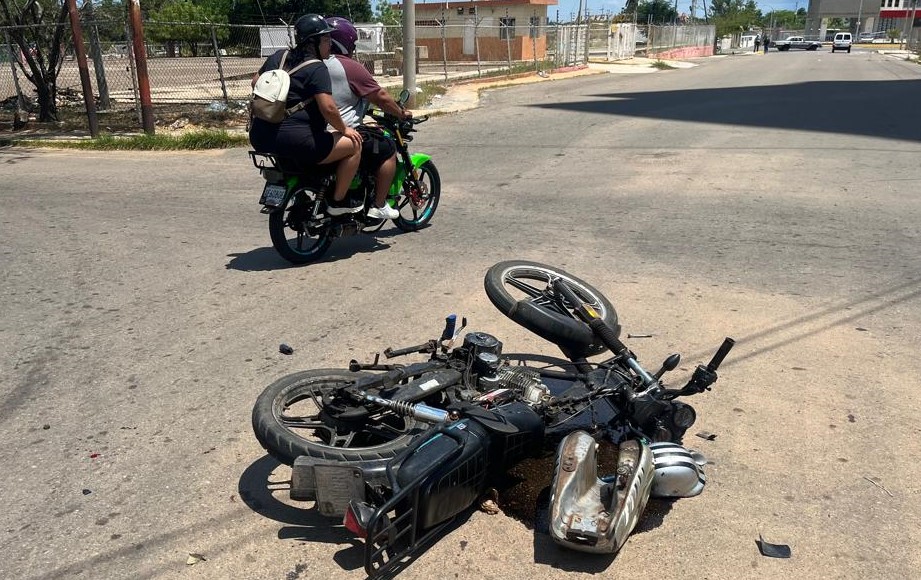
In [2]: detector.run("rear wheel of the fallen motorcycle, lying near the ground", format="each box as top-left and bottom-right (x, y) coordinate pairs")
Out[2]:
(252, 369), (424, 465)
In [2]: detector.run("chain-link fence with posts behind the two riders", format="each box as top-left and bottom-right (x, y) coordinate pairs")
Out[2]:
(0, 18), (607, 130)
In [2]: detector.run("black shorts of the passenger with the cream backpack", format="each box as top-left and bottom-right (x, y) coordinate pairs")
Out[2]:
(249, 119), (334, 165)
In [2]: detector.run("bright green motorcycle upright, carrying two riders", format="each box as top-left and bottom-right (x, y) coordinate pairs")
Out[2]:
(249, 91), (441, 264)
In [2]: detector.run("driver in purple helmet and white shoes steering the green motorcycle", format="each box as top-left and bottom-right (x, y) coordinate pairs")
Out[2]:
(326, 16), (412, 219)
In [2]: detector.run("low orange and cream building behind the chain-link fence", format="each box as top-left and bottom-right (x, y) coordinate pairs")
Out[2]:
(394, 0), (557, 61)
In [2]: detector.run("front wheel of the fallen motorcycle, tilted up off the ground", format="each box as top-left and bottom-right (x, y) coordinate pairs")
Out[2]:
(483, 260), (620, 357)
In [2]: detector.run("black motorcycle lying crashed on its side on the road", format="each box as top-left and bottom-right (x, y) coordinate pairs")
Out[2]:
(253, 261), (733, 577)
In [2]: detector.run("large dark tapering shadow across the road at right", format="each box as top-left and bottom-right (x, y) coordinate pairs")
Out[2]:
(533, 80), (921, 142)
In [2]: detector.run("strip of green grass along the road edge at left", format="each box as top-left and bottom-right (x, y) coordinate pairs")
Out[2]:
(10, 129), (249, 151)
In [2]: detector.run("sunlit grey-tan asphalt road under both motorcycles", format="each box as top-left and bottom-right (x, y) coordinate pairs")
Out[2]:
(0, 52), (921, 580)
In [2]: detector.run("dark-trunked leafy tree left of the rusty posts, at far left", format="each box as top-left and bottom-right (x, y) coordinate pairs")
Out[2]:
(0, 0), (72, 121)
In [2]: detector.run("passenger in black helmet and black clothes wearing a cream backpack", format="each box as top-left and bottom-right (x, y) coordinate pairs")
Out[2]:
(249, 14), (361, 215)
